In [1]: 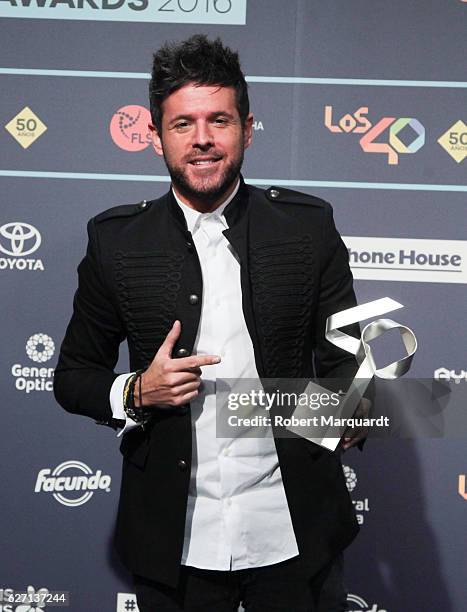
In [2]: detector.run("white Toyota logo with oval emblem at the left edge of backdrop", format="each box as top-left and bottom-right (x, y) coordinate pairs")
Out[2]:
(0, 221), (44, 271)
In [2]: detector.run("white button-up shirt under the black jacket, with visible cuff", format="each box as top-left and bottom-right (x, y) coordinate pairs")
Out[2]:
(110, 180), (298, 570)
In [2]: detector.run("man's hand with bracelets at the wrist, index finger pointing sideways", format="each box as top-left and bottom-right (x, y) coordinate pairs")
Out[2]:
(135, 321), (221, 407)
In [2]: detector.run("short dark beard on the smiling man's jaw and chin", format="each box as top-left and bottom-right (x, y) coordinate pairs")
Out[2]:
(164, 147), (244, 204)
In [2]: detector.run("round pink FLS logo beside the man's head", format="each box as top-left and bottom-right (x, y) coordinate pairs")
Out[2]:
(110, 104), (151, 153)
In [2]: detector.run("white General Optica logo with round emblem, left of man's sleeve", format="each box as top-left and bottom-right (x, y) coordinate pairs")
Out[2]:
(11, 334), (55, 393)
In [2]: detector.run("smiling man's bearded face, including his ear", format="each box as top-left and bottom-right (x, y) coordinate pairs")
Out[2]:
(153, 84), (253, 206)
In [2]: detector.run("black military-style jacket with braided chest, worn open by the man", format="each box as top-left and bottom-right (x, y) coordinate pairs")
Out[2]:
(54, 181), (359, 585)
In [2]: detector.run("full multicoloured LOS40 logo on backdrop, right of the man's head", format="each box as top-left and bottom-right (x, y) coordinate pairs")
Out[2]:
(324, 106), (425, 165)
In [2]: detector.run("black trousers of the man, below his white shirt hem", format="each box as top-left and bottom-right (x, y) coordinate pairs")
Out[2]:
(134, 555), (347, 612)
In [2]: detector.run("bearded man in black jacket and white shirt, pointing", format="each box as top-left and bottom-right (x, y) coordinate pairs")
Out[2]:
(55, 35), (370, 612)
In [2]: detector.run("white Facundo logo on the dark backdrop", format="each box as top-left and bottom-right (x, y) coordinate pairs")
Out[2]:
(34, 460), (112, 508)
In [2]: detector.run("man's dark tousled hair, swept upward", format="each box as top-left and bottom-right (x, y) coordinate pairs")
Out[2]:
(149, 34), (250, 134)
